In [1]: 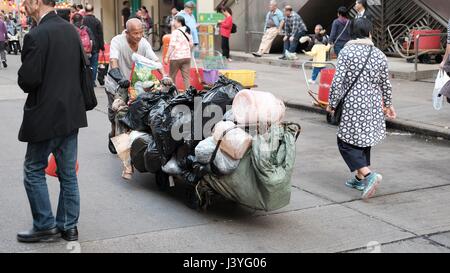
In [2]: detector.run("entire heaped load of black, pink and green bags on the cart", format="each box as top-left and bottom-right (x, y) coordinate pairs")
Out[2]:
(112, 54), (300, 211)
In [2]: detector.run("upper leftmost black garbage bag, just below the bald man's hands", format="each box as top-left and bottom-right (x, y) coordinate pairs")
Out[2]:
(119, 93), (163, 132)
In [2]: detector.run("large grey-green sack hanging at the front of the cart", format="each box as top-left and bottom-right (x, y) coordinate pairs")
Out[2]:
(203, 124), (300, 211)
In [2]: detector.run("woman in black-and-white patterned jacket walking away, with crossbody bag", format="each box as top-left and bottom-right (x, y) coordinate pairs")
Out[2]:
(328, 18), (396, 199)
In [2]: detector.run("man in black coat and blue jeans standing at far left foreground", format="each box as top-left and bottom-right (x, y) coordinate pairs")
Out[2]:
(17, 0), (87, 242)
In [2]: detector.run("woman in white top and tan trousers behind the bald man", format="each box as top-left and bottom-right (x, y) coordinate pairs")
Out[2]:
(164, 16), (194, 89)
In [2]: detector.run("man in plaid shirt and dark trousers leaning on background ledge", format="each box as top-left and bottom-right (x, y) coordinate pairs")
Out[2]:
(280, 5), (308, 60)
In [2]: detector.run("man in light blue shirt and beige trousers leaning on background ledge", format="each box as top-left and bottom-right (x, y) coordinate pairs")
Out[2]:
(252, 0), (284, 57)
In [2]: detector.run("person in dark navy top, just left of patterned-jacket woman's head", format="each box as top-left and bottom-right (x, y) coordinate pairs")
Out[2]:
(330, 7), (351, 56)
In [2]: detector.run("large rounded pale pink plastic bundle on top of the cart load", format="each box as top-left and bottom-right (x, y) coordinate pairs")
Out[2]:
(233, 90), (286, 124)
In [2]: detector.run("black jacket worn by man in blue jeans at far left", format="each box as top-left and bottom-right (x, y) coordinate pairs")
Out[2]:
(18, 12), (87, 142)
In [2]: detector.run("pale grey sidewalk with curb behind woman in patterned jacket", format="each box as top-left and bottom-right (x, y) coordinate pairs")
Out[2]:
(224, 52), (450, 140)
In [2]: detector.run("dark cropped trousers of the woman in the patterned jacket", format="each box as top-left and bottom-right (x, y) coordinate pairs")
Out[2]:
(337, 138), (372, 172)
